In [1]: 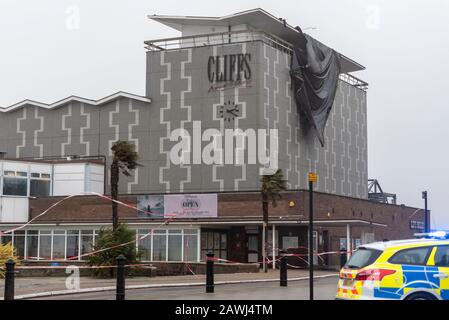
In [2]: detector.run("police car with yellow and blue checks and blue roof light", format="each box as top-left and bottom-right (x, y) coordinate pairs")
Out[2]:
(336, 232), (449, 300)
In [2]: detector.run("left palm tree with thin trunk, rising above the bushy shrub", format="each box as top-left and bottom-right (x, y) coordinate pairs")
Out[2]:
(111, 140), (139, 231)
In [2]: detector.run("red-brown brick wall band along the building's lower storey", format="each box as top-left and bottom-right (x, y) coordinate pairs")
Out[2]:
(30, 191), (424, 266)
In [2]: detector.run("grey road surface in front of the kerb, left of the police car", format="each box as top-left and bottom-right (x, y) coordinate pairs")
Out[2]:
(32, 275), (337, 301)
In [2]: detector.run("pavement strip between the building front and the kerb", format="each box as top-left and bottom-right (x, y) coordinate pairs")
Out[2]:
(0, 269), (338, 299)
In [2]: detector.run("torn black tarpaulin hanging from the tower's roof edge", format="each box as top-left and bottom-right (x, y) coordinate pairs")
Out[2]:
(290, 30), (340, 147)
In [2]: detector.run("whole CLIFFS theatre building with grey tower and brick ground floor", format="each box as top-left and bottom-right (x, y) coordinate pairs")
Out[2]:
(0, 9), (424, 267)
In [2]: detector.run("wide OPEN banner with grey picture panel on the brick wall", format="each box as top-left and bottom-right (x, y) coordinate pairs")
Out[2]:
(137, 194), (218, 219)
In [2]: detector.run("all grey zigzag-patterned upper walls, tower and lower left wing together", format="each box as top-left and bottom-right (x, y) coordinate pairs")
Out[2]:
(0, 41), (367, 198)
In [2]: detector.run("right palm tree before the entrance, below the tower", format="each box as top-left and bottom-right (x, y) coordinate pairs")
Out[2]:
(260, 169), (287, 272)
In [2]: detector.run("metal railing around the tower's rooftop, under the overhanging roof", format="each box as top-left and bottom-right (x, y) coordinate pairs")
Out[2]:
(144, 30), (368, 91)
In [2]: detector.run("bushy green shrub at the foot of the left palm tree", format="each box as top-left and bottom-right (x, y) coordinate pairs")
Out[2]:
(87, 224), (138, 277)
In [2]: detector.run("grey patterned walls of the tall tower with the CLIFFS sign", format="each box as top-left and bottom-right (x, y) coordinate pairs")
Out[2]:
(147, 41), (368, 198)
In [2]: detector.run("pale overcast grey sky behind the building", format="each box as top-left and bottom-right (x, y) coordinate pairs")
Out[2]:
(0, 0), (449, 229)
